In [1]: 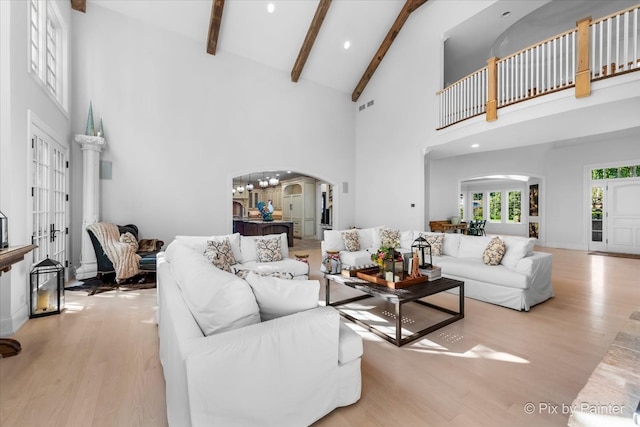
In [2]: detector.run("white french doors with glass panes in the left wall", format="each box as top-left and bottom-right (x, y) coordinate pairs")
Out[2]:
(31, 125), (69, 267)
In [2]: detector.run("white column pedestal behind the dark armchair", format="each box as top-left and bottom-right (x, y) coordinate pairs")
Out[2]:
(76, 135), (106, 280)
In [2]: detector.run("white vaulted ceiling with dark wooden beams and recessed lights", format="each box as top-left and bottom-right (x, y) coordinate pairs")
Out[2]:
(71, 0), (427, 102)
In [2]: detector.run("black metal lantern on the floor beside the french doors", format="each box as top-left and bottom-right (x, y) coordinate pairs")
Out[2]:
(29, 258), (64, 318)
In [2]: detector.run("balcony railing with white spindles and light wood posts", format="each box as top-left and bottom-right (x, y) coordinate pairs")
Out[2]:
(437, 5), (640, 129)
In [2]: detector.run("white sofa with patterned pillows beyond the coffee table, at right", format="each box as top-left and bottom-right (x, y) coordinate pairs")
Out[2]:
(321, 227), (554, 311)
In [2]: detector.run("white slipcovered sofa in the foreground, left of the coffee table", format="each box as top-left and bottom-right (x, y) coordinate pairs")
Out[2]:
(157, 238), (362, 427)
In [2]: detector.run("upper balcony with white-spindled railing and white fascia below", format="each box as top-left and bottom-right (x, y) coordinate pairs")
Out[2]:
(434, 5), (640, 155)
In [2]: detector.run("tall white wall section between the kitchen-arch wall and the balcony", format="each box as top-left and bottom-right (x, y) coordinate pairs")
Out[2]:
(354, 1), (493, 230)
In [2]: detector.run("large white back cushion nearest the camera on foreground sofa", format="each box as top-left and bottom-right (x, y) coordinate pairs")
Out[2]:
(166, 240), (260, 335)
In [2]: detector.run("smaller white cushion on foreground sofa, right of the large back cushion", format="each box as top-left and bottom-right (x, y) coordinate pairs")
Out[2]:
(247, 273), (320, 321)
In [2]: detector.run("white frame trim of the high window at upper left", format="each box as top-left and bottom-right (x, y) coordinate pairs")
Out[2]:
(27, 0), (69, 118)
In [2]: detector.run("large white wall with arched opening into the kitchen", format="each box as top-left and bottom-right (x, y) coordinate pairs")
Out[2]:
(73, 4), (355, 268)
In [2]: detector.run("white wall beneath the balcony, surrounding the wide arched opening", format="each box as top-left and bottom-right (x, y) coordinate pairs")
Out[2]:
(428, 136), (640, 250)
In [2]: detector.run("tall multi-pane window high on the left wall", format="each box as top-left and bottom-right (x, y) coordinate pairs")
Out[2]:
(29, 0), (67, 111)
